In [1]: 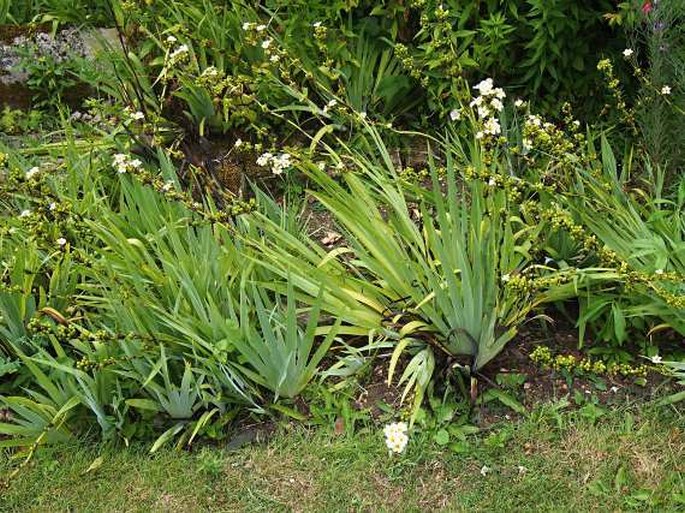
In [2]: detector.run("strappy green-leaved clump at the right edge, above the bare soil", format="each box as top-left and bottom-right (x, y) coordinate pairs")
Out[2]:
(570, 150), (685, 343)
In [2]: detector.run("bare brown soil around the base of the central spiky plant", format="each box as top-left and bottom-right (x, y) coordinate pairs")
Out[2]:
(336, 321), (674, 427)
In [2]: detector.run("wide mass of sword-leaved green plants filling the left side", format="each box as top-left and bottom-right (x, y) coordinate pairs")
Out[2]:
(0, 140), (335, 456)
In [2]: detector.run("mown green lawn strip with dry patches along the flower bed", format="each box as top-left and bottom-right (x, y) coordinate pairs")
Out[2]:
(0, 406), (685, 512)
